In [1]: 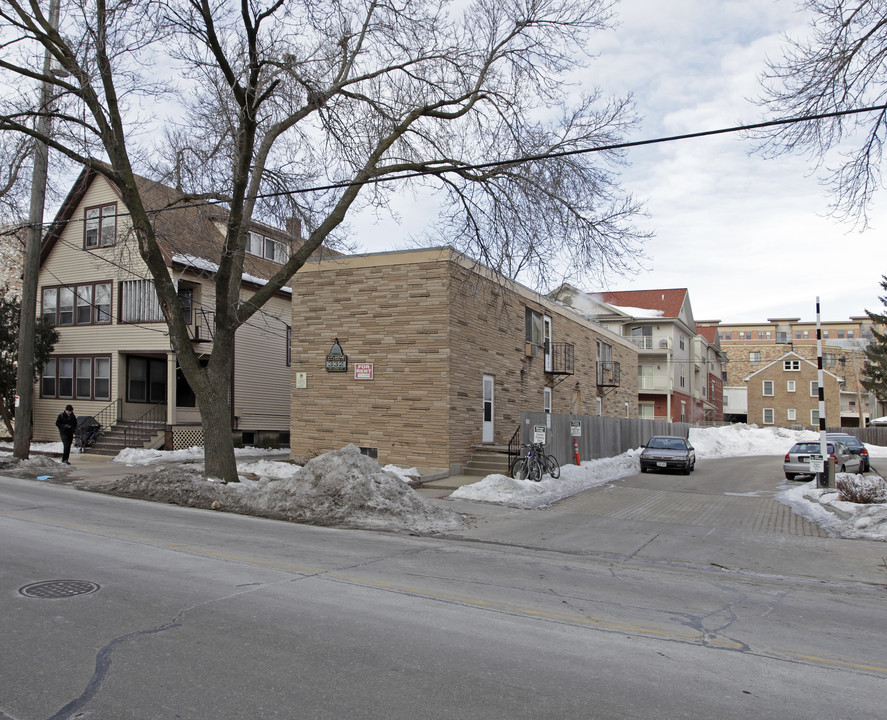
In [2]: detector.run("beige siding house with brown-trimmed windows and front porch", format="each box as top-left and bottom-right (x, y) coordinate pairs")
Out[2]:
(34, 171), (298, 449)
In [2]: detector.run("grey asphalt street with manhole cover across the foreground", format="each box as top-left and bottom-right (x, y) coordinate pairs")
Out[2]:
(0, 466), (887, 720)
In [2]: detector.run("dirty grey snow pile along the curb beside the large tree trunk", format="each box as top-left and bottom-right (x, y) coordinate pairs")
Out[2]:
(86, 445), (466, 534)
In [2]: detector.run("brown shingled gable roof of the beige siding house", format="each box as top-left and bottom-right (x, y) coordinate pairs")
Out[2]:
(40, 168), (339, 280)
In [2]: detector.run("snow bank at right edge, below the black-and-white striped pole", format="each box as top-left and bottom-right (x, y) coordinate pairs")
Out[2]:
(776, 473), (887, 541)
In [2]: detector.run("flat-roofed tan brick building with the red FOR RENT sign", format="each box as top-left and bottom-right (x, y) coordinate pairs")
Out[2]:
(290, 248), (638, 473)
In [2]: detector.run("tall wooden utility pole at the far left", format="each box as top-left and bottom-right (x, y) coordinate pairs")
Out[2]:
(12, 0), (59, 460)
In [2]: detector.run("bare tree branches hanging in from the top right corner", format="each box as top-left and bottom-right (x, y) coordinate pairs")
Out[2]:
(760, 0), (887, 227)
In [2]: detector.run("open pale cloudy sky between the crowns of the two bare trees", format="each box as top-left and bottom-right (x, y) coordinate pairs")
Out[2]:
(352, 0), (887, 322)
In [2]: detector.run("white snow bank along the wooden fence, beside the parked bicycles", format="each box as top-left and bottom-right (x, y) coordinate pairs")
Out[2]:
(450, 450), (641, 510)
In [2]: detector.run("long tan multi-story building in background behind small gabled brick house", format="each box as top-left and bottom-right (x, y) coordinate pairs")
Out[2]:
(697, 315), (884, 427)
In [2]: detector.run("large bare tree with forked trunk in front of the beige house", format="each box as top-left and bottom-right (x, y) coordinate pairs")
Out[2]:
(0, 0), (644, 481)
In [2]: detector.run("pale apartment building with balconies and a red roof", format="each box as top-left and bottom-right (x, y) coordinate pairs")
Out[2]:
(552, 285), (726, 423)
